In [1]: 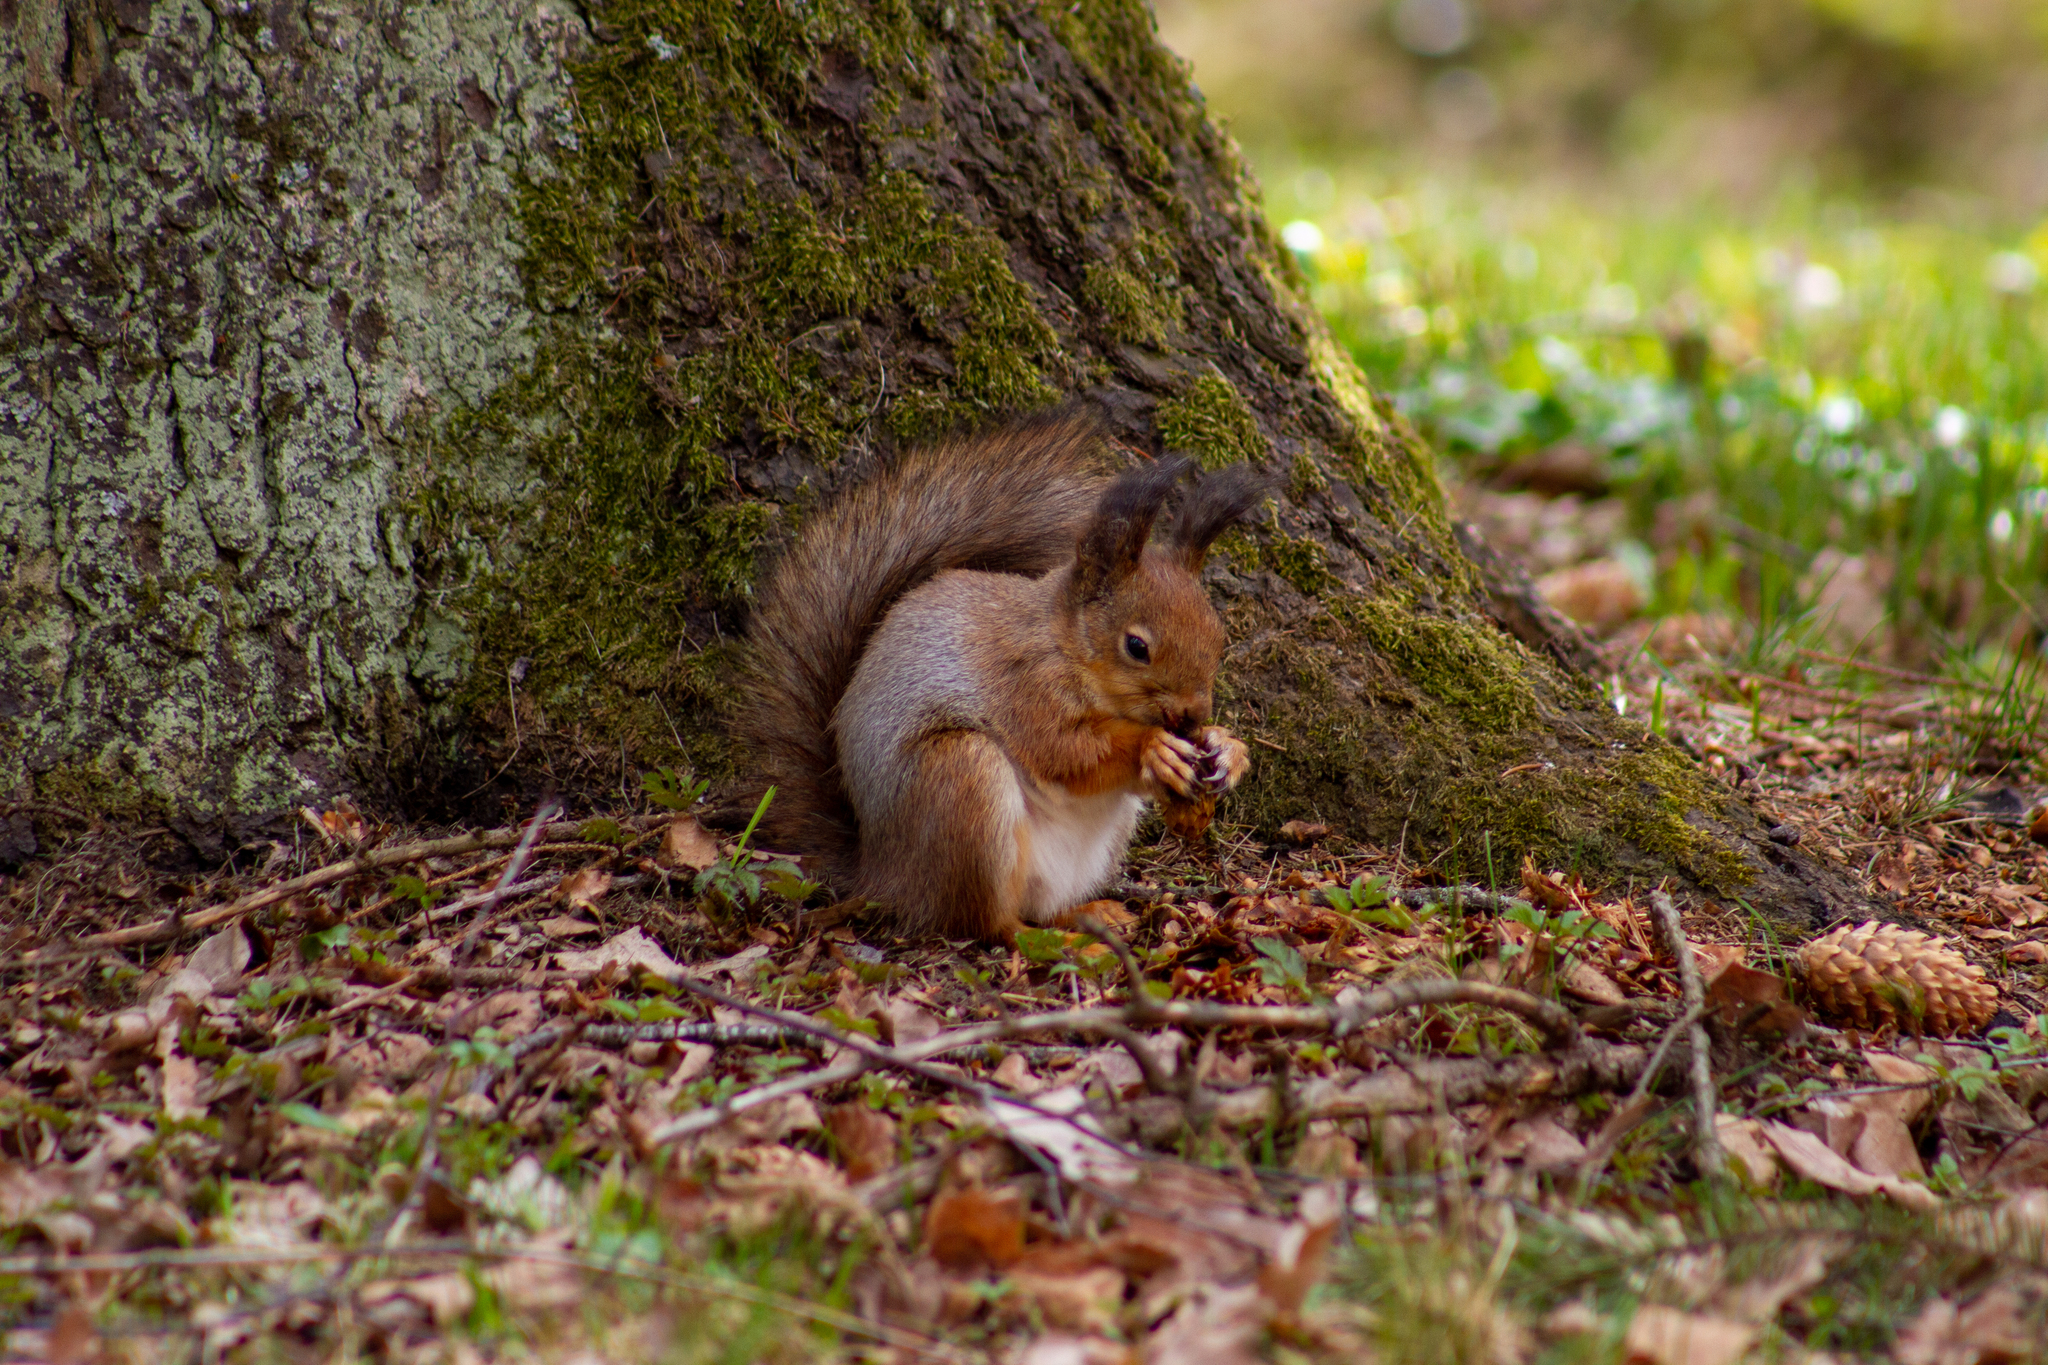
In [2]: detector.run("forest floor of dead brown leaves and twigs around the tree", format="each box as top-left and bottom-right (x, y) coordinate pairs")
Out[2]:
(0, 589), (2048, 1365)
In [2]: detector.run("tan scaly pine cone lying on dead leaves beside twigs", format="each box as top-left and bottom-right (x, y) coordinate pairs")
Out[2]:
(1800, 919), (1999, 1038)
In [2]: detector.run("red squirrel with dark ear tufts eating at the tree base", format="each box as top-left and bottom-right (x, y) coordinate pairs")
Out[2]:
(741, 411), (1268, 941)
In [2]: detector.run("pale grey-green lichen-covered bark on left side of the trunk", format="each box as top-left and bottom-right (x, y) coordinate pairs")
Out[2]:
(0, 0), (589, 851)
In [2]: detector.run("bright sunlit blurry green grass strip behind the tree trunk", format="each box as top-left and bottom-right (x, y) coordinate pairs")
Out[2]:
(1268, 168), (2048, 659)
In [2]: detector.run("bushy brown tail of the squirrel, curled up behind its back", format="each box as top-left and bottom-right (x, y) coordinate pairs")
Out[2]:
(739, 407), (1102, 888)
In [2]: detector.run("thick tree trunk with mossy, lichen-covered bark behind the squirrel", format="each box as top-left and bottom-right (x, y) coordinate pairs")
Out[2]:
(0, 0), (1853, 923)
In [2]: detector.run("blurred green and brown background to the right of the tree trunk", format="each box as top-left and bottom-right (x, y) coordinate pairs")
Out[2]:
(1159, 0), (2048, 673)
